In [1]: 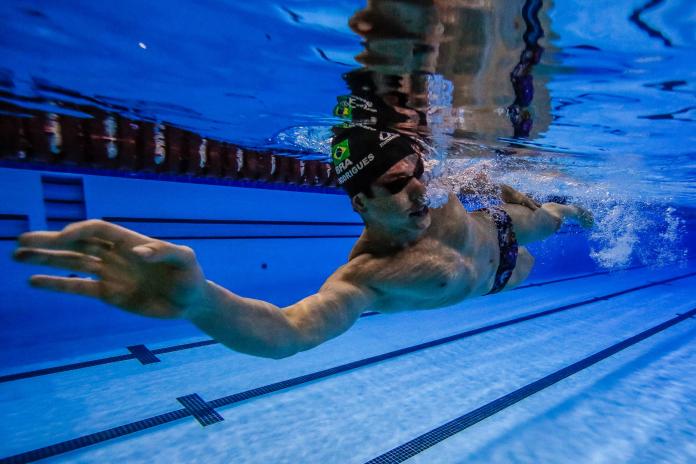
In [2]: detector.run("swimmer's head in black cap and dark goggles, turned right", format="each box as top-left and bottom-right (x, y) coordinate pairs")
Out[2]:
(332, 127), (430, 232)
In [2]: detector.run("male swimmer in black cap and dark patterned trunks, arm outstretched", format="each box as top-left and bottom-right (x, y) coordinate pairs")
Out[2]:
(14, 127), (591, 358)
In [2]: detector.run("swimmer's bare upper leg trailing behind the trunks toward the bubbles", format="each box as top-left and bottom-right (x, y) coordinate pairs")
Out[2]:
(500, 203), (593, 245)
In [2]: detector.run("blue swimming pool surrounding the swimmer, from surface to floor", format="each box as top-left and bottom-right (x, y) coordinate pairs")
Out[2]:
(0, 1), (696, 463)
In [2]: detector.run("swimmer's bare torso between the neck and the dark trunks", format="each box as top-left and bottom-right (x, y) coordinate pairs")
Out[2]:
(346, 196), (499, 312)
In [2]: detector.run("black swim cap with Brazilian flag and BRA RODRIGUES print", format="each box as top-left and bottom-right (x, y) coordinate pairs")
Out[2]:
(331, 125), (418, 197)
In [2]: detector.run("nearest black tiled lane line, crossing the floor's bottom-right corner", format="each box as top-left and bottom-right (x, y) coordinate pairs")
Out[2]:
(366, 308), (696, 464)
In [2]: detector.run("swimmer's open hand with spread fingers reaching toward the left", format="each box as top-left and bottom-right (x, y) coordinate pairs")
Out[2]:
(14, 220), (208, 318)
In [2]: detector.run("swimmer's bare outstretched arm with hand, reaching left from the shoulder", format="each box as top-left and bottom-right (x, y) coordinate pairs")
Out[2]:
(14, 220), (375, 358)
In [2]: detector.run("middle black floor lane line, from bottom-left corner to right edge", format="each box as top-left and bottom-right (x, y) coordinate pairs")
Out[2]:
(0, 272), (696, 464)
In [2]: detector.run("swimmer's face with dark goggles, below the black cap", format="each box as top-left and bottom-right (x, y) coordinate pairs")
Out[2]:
(353, 154), (430, 230)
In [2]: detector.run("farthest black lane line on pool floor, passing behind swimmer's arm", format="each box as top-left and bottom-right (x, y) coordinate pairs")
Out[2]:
(0, 265), (668, 383)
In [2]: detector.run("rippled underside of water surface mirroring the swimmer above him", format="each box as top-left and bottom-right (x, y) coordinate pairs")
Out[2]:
(0, 0), (696, 263)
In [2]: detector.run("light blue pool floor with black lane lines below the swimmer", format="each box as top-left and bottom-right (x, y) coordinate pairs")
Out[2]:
(0, 262), (696, 464)
